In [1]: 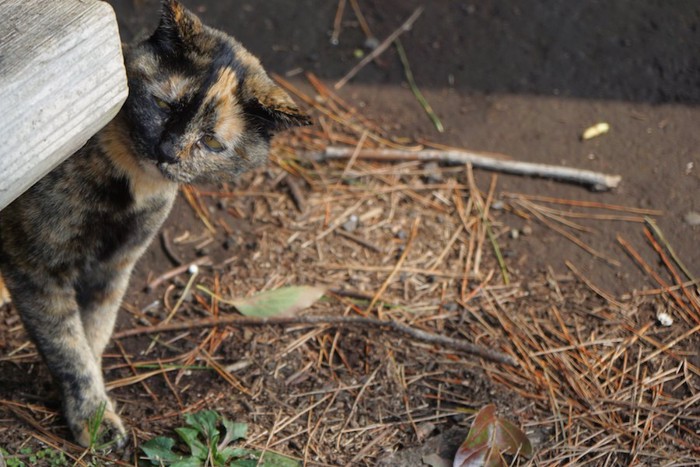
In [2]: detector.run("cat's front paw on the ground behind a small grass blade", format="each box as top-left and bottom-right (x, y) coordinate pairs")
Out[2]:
(68, 401), (127, 450)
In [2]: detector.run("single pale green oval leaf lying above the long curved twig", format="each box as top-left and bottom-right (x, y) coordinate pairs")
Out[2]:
(230, 285), (325, 318)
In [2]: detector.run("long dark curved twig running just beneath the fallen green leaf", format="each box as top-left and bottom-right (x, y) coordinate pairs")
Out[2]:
(114, 315), (518, 366)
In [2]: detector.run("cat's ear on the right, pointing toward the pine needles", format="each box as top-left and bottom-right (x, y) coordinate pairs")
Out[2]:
(244, 76), (311, 133)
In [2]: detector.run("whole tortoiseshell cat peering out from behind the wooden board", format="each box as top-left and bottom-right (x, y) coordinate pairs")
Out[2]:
(0, 0), (309, 446)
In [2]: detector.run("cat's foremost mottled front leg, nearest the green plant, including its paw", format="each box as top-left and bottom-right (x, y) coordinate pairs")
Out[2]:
(8, 286), (126, 447)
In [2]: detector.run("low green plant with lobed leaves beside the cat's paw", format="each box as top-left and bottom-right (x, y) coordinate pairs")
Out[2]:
(141, 410), (301, 467)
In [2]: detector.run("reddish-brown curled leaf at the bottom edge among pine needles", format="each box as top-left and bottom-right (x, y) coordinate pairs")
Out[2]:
(453, 404), (532, 467)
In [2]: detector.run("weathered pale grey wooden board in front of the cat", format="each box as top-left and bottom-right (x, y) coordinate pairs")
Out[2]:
(0, 0), (127, 209)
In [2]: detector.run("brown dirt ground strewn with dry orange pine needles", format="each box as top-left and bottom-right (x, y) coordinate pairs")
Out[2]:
(0, 0), (700, 465)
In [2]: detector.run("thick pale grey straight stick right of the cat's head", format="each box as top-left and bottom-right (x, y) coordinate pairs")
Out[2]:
(307, 146), (622, 191)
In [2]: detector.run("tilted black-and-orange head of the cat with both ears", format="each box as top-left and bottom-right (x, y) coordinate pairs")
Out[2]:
(122, 0), (309, 183)
